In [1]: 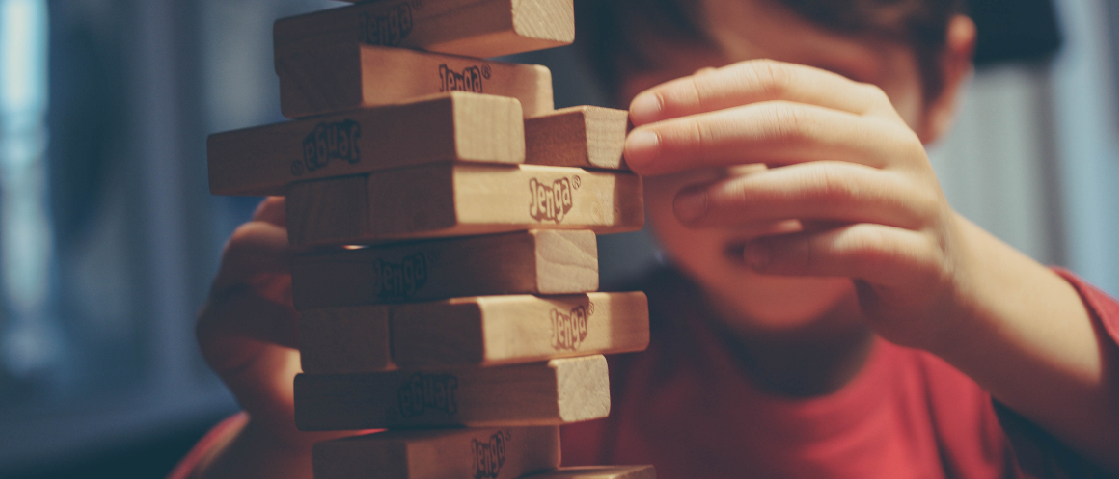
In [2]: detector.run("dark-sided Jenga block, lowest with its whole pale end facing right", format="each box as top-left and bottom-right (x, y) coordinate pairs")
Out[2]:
(295, 356), (610, 431)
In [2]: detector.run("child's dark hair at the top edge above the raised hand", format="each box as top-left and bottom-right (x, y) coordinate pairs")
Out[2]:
(575, 0), (965, 100)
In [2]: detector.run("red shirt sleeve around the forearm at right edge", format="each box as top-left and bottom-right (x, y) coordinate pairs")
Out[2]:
(995, 269), (1119, 479)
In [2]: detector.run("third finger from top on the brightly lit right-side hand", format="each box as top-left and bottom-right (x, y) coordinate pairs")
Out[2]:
(673, 161), (940, 228)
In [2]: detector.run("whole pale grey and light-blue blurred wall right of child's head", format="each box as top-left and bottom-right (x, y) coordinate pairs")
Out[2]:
(930, 0), (1119, 295)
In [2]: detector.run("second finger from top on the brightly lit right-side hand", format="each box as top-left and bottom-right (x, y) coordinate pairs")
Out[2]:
(624, 101), (923, 175)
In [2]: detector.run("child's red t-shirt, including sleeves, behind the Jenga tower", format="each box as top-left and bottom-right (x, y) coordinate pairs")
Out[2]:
(171, 271), (1119, 479)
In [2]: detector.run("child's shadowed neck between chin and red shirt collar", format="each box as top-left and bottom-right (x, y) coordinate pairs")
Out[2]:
(716, 297), (874, 397)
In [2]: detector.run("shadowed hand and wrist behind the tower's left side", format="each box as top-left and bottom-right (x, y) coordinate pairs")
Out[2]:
(197, 198), (354, 478)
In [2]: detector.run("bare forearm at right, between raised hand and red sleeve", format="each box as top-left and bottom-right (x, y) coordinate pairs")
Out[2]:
(933, 218), (1119, 471)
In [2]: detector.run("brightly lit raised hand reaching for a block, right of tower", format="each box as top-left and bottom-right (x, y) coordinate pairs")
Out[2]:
(626, 62), (960, 347)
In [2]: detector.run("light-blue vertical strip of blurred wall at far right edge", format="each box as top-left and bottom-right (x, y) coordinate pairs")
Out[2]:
(1053, 0), (1119, 295)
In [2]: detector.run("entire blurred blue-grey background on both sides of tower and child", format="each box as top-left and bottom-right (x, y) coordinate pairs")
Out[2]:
(0, 0), (1119, 478)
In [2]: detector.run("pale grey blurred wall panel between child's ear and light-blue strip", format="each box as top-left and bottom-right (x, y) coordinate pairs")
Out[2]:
(929, 65), (1065, 264)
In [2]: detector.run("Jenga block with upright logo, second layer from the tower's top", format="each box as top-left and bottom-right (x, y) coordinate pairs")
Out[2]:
(276, 44), (555, 118)
